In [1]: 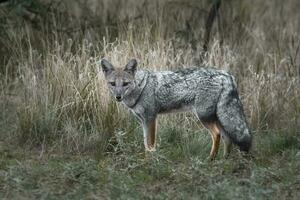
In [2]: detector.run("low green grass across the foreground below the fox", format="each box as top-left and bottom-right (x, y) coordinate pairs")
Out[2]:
(0, 131), (300, 199)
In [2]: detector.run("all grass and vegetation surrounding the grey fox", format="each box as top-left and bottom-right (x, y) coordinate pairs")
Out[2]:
(0, 0), (300, 199)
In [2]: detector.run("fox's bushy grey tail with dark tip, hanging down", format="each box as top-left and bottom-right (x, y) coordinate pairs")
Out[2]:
(217, 80), (252, 152)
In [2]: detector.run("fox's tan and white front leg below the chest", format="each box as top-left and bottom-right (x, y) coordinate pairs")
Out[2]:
(143, 119), (156, 151)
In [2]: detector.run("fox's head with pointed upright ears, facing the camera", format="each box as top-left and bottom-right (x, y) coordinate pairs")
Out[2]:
(101, 59), (137, 101)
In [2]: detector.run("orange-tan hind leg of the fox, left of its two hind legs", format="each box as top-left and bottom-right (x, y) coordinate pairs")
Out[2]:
(203, 122), (220, 160)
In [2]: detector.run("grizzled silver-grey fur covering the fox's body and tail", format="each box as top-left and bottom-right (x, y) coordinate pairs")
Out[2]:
(102, 59), (252, 156)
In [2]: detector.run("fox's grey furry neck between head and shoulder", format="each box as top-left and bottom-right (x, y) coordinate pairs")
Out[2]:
(123, 71), (149, 108)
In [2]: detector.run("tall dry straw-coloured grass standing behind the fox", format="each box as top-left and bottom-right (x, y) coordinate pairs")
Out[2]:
(0, 0), (300, 155)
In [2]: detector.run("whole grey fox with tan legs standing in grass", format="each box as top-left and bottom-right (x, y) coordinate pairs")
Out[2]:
(101, 59), (252, 159)
